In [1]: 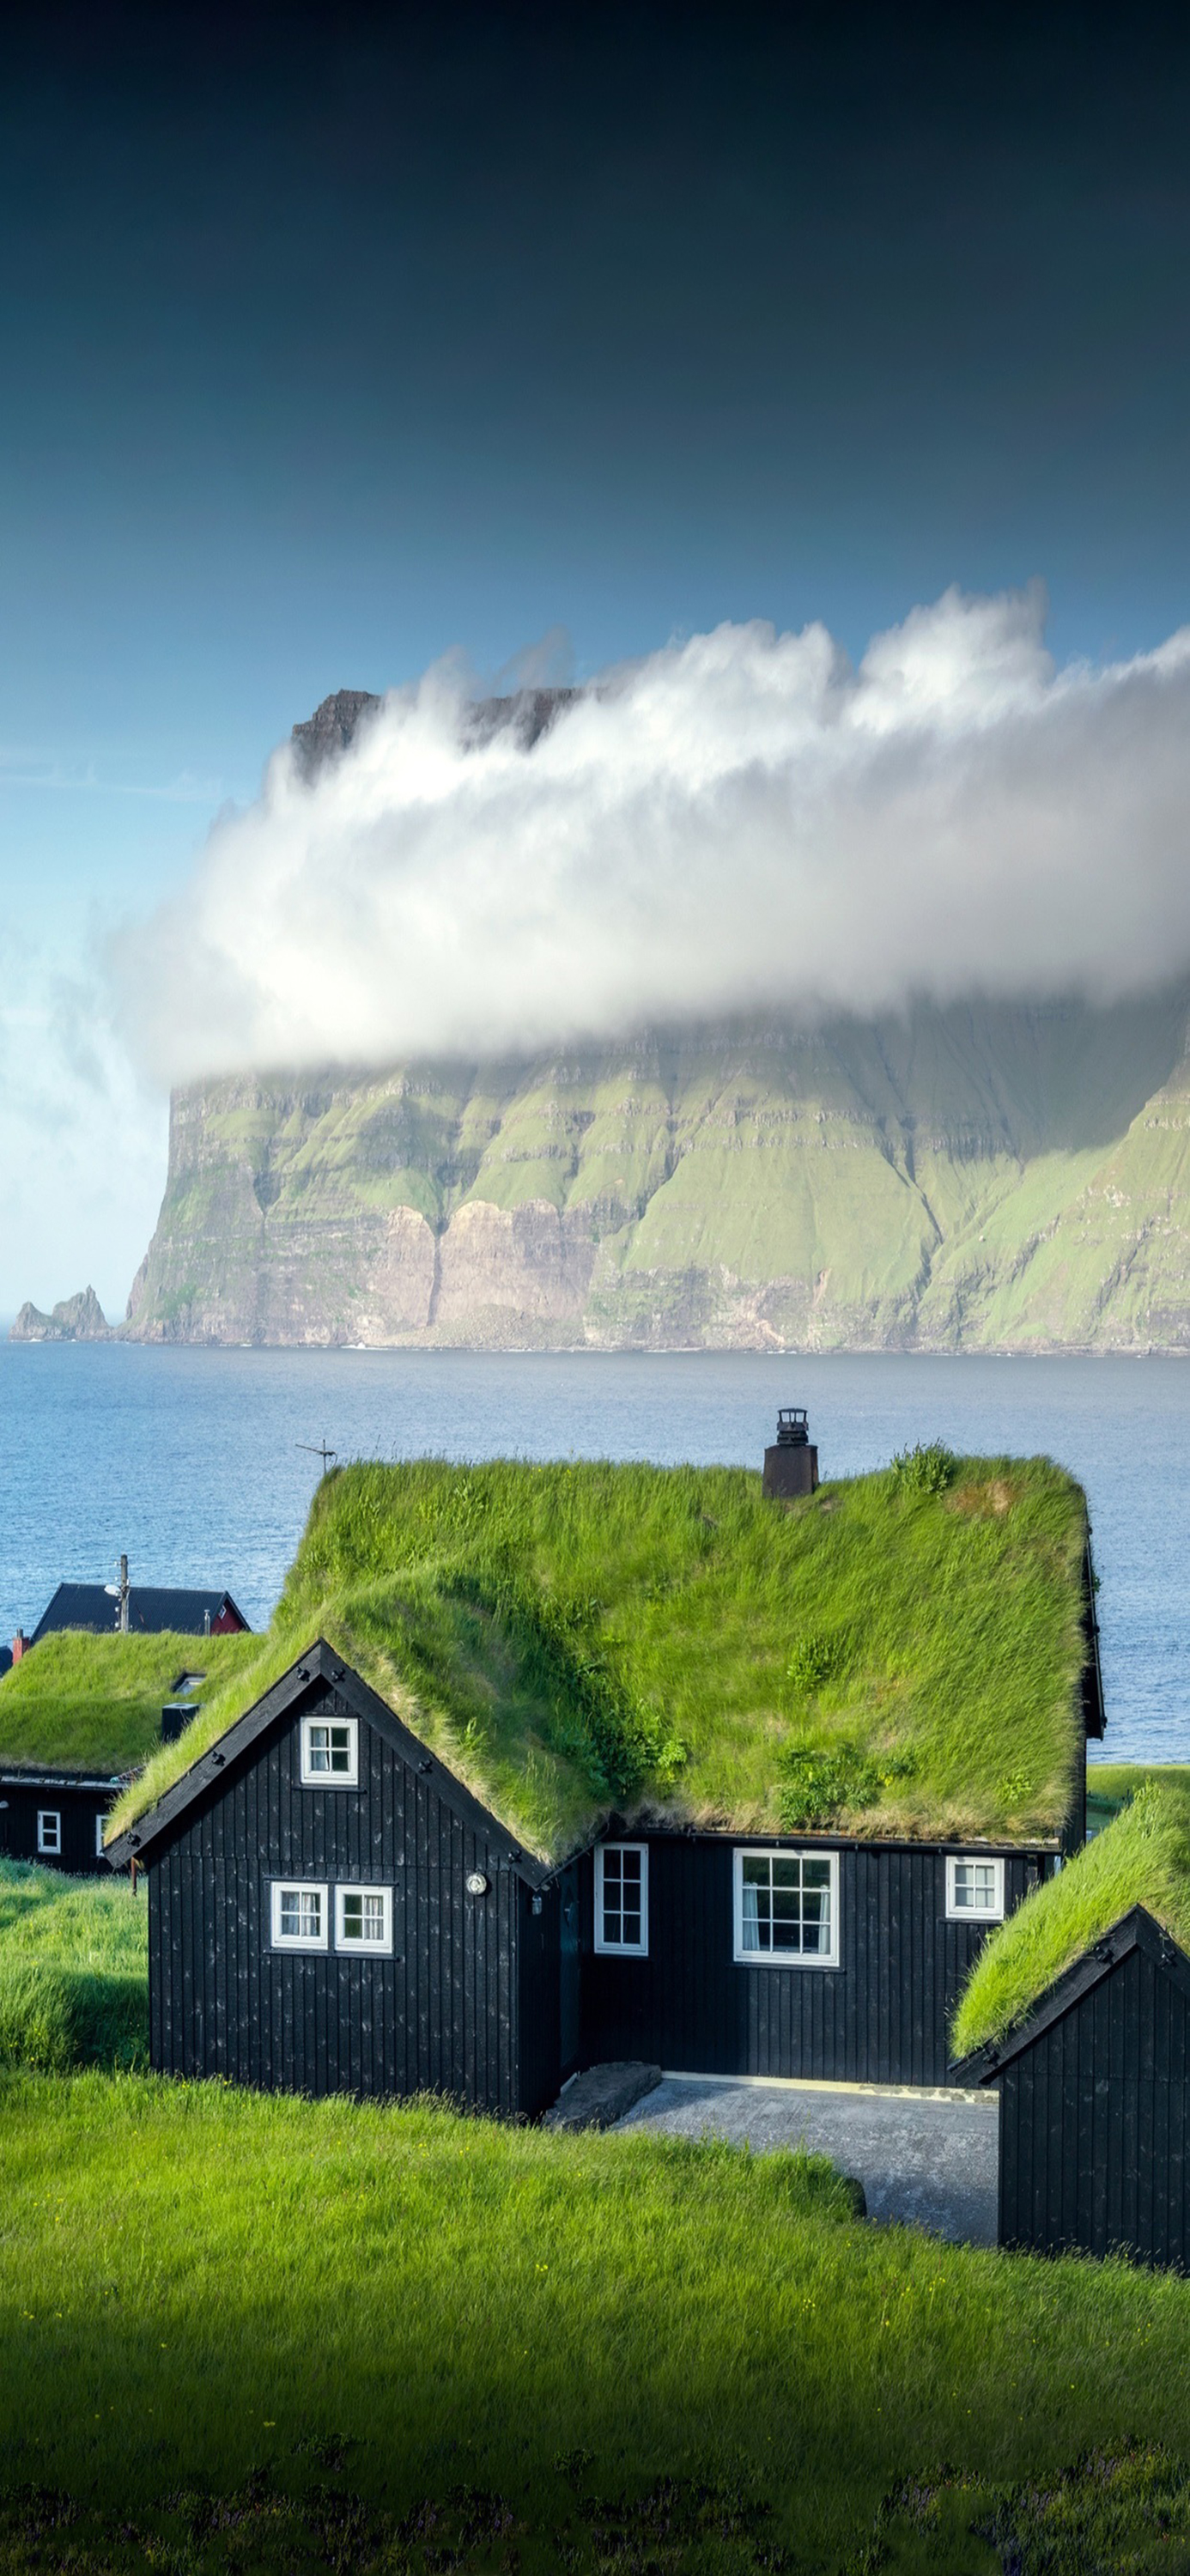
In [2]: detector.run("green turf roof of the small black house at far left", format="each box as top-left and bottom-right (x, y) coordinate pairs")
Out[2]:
(0, 1628), (260, 1777)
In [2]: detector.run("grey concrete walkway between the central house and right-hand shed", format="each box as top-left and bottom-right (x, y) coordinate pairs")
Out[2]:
(618, 2076), (999, 2246)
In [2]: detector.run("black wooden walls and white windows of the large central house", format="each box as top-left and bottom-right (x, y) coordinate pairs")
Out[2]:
(108, 1607), (1102, 2117)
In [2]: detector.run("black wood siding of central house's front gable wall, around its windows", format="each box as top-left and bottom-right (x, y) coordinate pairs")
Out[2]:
(149, 1685), (525, 2112)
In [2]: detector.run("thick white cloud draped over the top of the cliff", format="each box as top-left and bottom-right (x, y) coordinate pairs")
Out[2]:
(116, 590), (1190, 1082)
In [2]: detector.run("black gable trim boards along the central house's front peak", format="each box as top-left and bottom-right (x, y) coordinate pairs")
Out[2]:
(106, 1638), (551, 1888)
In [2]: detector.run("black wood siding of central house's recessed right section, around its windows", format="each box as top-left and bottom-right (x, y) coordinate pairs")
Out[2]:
(582, 1834), (1038, 2084)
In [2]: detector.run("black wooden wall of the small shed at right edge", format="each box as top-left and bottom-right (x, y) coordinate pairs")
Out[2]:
(999, 1947), (1190, 2272)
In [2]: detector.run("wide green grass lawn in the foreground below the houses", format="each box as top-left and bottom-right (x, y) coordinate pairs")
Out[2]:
(0, 2074), (1190, 2576)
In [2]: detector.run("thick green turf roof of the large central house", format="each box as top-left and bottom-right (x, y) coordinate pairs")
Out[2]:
(113, 1458), (1087, 1860)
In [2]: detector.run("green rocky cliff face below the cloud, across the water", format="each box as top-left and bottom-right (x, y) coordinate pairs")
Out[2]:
(126, 987), (1190, 1350)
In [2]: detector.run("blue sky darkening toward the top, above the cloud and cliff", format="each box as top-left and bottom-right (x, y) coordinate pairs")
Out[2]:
(0, 8), (1190, 1311)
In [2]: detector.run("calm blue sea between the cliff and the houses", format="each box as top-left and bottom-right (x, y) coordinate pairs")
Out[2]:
(0, 1342), (1190, 1762)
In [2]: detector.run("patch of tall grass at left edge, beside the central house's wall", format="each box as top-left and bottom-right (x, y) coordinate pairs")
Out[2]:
(0, 1860), (149, 2071)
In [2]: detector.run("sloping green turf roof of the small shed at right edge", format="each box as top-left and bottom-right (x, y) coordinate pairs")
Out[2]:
(953, 1780), (1190, 2058)
